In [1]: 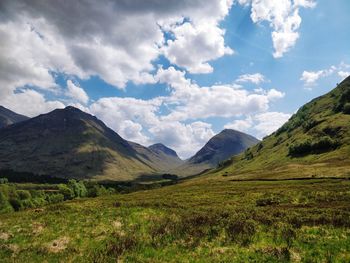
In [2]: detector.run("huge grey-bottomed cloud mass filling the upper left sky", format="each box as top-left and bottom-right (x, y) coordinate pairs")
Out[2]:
(0, 0), (232, 93)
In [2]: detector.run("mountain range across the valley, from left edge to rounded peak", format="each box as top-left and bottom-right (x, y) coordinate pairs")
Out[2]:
(0, 106), (258, 181)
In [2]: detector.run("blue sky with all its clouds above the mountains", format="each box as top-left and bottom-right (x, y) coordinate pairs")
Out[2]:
(0, 0), (350, 158)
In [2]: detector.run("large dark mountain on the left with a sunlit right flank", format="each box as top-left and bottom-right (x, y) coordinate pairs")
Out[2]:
(0, 107), (154, 180)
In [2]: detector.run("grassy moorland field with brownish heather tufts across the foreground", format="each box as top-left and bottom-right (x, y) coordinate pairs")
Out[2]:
(0, 175), (350, 262)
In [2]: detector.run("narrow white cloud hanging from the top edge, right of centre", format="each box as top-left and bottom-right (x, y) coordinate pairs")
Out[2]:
(238, 0), (316, 58)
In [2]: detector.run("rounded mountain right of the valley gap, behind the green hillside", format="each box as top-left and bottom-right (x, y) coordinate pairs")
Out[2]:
(171, 129), (259, 175)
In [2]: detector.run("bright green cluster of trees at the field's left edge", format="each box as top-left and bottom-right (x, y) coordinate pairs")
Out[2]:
(0, 178), (115, 213)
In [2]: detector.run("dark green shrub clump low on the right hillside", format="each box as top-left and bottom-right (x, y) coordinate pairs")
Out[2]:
(289, 136), (339, 157)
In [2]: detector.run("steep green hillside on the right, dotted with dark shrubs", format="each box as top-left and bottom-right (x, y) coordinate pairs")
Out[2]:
(218, 77), (350, 178)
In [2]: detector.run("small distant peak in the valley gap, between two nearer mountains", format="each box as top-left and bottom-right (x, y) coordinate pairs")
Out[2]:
(129, 142), (183, 174)
